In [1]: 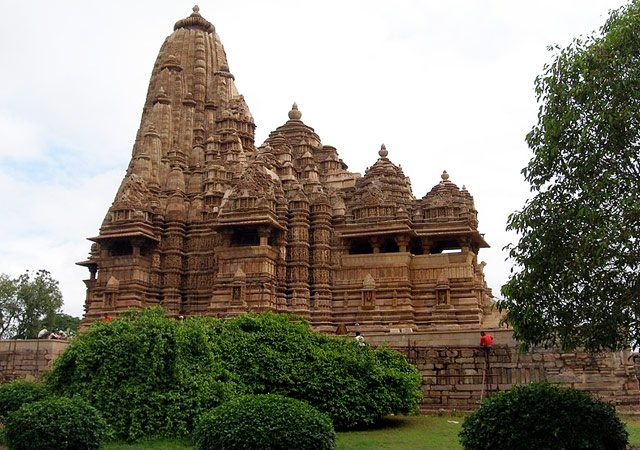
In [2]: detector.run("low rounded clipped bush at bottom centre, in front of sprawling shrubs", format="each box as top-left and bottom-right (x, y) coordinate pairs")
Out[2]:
(194, 395), (336, 450)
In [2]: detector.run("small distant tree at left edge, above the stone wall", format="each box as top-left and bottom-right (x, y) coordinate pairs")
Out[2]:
(0, 270), (62, 339)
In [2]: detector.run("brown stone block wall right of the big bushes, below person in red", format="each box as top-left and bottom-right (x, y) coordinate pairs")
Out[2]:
(365, 330), (640, 412)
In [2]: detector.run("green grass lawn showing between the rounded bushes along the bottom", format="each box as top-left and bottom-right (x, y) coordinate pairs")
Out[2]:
(0, 416), (640, 450)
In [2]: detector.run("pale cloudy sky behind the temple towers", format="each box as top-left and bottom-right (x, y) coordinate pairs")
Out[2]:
(0, 0), (626, 316)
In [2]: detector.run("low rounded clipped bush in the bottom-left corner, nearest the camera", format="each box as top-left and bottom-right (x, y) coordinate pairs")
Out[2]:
(5, 397), (107, 450)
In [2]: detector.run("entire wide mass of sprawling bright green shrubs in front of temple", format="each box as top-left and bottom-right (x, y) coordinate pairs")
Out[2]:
(46, 309), (422, 440)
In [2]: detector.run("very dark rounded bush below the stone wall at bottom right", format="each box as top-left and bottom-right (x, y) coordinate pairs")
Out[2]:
(460, 383), (628, 450)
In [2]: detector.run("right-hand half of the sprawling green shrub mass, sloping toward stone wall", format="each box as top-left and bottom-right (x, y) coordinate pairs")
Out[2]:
(211, 312), (422, 429)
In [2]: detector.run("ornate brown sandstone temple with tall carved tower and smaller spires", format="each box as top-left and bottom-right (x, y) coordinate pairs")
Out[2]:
(78, 7), (498, 333)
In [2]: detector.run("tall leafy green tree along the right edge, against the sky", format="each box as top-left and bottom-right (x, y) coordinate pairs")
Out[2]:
(498, 0), (640, 350)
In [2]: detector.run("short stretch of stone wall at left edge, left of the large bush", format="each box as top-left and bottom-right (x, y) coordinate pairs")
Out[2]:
(0, 339), (69, 382)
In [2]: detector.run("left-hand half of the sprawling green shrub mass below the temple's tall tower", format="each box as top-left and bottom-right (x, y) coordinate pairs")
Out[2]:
(46, 308), (235, 440)
